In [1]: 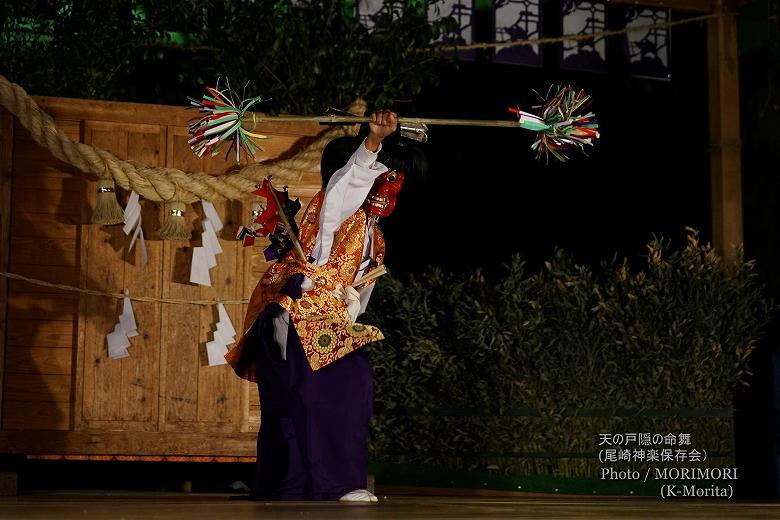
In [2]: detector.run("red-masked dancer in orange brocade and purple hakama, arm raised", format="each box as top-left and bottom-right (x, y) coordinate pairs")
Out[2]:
(226, 111), (412, 502)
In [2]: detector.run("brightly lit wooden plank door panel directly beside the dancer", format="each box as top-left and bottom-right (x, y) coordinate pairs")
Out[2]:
(160, 127), (247, 433)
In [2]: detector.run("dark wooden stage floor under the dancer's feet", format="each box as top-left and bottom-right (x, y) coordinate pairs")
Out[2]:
(0, 492), (780, 520)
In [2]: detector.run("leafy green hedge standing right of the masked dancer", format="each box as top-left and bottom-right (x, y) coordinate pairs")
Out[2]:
(367, 232), (772, 474)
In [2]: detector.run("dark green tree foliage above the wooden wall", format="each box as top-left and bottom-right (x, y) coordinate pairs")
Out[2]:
(0, 0), (452, 113)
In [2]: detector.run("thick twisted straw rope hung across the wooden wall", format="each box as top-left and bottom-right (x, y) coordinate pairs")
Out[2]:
(0, 75), (366, 203)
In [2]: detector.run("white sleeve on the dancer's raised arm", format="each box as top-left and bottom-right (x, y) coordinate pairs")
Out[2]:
(312, 141), (387, 266)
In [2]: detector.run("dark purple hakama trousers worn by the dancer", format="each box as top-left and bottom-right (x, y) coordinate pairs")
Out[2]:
(247, 304), (373, 500)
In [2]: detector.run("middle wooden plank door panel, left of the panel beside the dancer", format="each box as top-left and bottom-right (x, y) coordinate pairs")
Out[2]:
(76, 121), (166, 431)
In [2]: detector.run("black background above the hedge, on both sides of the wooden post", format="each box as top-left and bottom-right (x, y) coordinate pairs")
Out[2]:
(381, 0), (780, 498)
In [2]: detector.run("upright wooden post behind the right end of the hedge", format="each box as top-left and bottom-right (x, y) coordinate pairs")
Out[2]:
(707, 9), (742, 260)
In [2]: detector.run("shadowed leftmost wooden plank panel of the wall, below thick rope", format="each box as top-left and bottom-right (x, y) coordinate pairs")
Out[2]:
(2, 116), (83, 430)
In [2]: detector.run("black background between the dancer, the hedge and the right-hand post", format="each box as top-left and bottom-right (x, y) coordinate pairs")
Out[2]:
(382, 8), (711, 275)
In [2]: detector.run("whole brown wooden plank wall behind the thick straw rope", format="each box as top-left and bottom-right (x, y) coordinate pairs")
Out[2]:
(0, 98), (323, 457)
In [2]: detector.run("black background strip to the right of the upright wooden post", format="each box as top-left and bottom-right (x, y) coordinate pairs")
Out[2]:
(735, 0), (780, 497)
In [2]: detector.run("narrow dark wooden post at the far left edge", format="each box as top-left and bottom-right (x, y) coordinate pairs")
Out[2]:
(0, 109), (14, 424)
